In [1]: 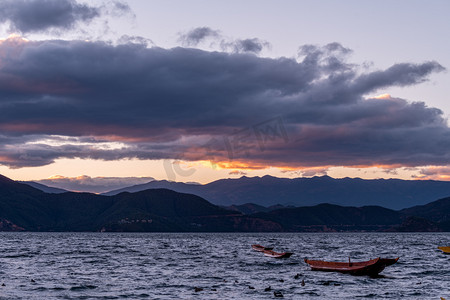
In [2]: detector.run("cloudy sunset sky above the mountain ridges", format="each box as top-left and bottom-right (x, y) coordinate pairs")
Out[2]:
(0, 0), (450, 190)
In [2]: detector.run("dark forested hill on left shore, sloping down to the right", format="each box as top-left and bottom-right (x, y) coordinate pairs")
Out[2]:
(0, 175), (282, 232)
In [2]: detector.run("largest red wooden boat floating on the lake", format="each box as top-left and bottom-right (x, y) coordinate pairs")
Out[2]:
(305, 257), (399, 276)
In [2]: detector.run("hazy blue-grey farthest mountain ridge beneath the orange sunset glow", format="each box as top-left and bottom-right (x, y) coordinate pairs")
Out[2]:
(105, 176), (450, 209)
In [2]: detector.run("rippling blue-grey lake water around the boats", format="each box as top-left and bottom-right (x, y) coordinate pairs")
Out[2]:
(0, 233), (450, 299)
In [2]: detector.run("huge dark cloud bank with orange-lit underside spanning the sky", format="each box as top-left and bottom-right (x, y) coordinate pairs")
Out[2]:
(0, 39), (450, 169)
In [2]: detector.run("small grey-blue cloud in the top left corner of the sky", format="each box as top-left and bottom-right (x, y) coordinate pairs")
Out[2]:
(0, 0), (130, 33)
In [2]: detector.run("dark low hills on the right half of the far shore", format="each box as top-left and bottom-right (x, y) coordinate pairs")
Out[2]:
(230, 197), (450, 232)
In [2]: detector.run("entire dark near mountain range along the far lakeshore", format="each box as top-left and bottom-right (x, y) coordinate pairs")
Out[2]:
(0, 175), (450, 232)
